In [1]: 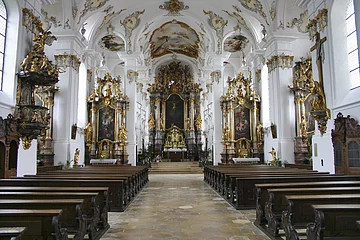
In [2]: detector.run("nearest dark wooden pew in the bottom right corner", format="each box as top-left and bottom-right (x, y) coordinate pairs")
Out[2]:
(306, 204), (360, 240)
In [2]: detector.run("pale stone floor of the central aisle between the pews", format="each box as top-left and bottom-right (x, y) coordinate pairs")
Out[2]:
(101, 174), (269, 240)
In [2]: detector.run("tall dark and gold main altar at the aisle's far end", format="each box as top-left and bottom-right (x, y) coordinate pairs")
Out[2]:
(148, 61), (202, 161)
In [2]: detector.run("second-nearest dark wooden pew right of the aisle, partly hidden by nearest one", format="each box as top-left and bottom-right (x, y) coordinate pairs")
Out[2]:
(281, 194), (360, 239)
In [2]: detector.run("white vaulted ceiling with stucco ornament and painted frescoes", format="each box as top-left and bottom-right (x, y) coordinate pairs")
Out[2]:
(41, 0), (306, 72)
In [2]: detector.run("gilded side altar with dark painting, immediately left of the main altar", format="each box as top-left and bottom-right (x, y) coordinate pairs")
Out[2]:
(85, 73), (129, 164)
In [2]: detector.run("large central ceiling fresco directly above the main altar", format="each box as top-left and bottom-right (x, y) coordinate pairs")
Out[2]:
(150, 20), (200, 58)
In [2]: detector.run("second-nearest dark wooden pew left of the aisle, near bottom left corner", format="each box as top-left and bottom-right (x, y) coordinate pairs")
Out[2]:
(0, 209), (68, 240)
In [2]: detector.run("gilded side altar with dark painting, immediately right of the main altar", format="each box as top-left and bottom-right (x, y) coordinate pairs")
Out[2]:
(220, 73), (263, 164)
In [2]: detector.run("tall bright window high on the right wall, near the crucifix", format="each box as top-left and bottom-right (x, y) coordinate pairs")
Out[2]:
(346, 0), (360, 89)
